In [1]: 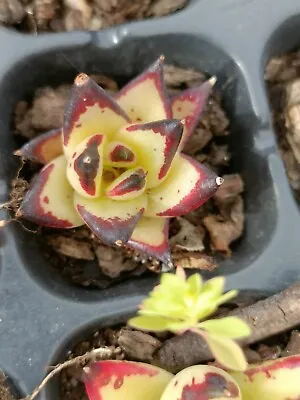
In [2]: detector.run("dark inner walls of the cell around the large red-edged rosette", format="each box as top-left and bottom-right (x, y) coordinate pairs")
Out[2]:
(0, 31), (277, 300)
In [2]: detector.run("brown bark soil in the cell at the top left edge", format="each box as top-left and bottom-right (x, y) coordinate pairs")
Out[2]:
(0, 0), (188, 34)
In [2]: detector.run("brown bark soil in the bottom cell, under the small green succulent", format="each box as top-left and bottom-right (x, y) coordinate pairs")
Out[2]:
(60, 327), (300, 400)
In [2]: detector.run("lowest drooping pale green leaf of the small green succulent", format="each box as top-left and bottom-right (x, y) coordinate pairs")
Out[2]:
(202, 333), (248, 371)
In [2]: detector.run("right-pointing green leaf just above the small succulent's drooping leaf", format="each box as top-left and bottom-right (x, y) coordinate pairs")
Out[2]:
(197, 317), (251, 339)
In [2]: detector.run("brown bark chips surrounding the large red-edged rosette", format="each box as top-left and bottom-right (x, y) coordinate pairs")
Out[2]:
(7, 66), (244, 288)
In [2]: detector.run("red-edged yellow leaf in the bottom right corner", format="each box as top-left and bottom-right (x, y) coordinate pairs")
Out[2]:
(230, 355), (300, 400)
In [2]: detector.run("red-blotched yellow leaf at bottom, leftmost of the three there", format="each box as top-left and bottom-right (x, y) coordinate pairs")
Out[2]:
(83, 360), (173, 400)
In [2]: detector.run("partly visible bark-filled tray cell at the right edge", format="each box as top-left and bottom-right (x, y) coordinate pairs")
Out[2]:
(262, 14), (300, 207)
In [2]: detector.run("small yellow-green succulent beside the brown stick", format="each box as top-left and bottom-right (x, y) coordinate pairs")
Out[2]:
(128, 268), (250, 370)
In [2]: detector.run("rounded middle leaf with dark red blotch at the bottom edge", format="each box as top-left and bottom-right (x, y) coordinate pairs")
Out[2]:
(160, 365), (242, 400)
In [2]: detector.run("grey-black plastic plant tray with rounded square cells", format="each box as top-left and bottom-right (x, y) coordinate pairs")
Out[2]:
(0, 0), (300, 400)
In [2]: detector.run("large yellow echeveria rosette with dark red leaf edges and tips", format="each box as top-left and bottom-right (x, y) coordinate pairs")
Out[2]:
(16, 54), (222, 264)
